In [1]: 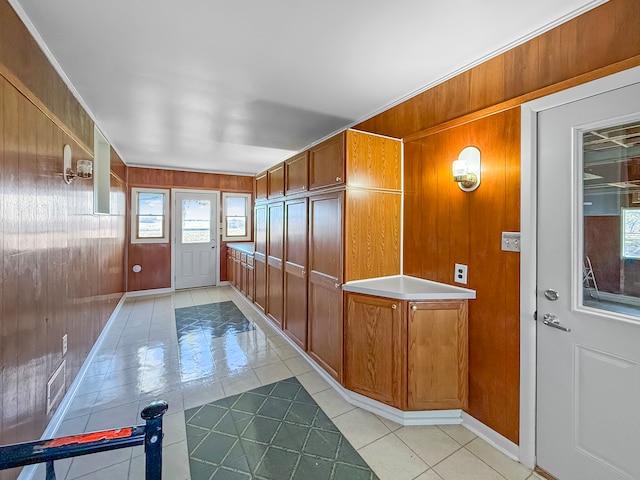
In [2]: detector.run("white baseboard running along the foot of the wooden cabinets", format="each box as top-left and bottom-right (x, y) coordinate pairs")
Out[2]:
(231, 285), (462, 426)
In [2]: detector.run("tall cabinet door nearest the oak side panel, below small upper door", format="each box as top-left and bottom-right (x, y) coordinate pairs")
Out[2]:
(307, 192), (344, 382)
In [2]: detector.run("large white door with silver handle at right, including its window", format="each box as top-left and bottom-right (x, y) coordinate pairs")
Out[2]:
(536, 80), (640, 480)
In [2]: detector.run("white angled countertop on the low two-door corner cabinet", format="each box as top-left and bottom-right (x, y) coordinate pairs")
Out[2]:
(342, 275), (476, 300)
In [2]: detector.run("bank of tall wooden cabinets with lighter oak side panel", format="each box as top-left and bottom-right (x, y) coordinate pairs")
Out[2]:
(254, 130), (402, 382)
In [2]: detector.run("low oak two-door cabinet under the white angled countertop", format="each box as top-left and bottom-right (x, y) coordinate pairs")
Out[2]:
(345, 293), (468, 410)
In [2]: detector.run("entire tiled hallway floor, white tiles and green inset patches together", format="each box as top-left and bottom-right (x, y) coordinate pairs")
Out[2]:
(36, 287), (540, 480)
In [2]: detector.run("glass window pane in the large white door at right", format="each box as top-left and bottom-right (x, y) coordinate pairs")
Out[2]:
(581, 121), (640, 316)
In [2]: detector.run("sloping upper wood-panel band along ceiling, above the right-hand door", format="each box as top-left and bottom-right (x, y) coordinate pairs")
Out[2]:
(354, 0), (640, 138)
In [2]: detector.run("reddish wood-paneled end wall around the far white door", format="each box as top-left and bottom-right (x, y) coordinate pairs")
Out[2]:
(127, 167), (253, 292)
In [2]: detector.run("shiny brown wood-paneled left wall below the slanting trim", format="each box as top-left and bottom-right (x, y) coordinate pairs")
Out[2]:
(0, 77), (126, 479)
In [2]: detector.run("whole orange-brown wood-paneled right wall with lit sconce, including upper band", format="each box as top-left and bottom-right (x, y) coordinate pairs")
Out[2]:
(354, 0), (640, 443)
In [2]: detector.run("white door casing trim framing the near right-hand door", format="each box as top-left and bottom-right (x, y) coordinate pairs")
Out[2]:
(518, 63), (640, 468)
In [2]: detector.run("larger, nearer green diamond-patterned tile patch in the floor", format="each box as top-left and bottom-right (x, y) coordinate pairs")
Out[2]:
(184, 377), (378, 480)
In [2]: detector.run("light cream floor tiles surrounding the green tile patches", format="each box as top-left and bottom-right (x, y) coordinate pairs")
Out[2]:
(37, 287), (540, 480)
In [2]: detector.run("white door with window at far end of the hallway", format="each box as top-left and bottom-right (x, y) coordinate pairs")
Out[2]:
(174, 191), (218, 289)
